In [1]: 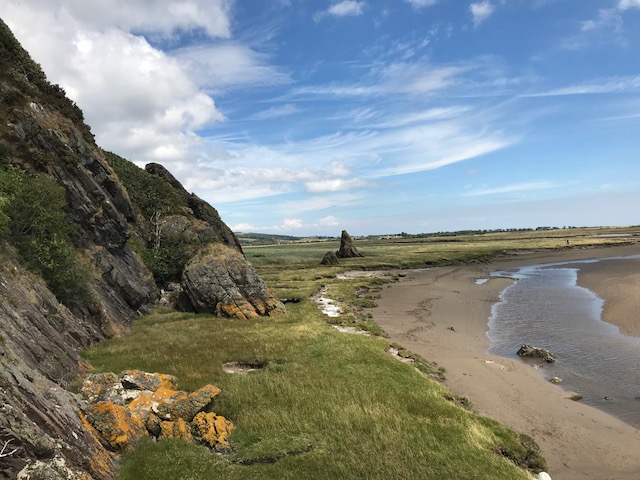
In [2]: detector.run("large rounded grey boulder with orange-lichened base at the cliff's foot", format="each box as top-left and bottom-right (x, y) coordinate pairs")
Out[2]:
(180, 244), (284, 319)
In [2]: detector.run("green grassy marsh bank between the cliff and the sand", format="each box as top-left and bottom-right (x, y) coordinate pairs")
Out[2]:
(84, 228), (636, 480)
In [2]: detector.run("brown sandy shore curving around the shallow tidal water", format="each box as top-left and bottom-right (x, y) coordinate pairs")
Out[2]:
(372, 244), (640, 480)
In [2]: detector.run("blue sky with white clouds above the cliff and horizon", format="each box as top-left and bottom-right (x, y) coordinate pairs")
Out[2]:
(0, 0), (640, 236)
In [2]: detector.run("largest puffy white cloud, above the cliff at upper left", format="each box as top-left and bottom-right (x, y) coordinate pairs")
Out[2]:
(2, 0), (290, 163)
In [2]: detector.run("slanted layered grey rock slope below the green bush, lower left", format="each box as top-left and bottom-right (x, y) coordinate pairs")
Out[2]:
(0, 256), (116, 479)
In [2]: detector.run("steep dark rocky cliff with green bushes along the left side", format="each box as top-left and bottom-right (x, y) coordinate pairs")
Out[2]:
(0, 20), (281, 479)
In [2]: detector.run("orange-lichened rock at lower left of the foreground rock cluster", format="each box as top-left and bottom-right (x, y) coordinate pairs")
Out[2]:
(87, 402), (147, 452)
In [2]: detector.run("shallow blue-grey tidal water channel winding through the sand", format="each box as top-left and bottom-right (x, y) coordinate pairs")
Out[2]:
(487, 256), (640, 428)
